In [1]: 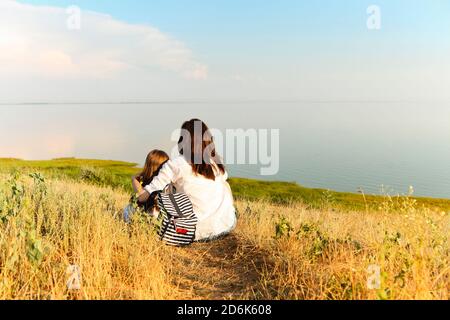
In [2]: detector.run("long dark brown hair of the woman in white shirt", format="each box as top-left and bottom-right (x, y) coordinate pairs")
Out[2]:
(178, 119), (225, 180)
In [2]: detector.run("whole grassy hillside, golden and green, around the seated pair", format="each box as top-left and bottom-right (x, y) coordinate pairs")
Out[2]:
(0, 159), (450, 300)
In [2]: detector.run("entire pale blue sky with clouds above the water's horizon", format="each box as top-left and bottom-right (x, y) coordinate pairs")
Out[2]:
(0, 0), (450, 103)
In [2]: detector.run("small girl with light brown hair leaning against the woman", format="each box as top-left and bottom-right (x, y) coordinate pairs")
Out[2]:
(124, 150), (169, 222)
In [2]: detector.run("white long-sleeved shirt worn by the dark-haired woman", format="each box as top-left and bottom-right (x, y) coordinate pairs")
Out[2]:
(144, 156), (236, 240)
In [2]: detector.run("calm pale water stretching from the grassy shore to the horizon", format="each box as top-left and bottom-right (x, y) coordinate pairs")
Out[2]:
(0, 102), (450, 198)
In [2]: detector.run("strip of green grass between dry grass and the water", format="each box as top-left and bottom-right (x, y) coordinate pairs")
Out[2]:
(0, 158), (450, 211)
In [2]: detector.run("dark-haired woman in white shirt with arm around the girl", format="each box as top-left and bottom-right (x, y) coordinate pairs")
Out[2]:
(138, 119), (236, 241)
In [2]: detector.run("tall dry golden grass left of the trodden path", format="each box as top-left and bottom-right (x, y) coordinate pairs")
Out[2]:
(0, 176), (174, 299)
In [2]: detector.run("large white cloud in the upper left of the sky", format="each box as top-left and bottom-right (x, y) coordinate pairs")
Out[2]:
(0, 0), (208, 79)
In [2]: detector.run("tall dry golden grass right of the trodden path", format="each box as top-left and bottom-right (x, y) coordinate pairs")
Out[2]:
(237, 197), (450, 299)
